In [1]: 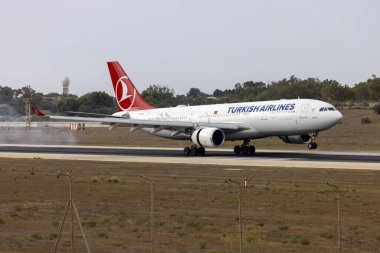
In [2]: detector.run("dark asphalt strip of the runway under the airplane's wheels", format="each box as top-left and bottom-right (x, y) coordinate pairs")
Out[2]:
(0, 145), (380, 164)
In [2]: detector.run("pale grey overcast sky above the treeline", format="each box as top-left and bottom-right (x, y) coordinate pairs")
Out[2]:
(0, 0), (380, 95)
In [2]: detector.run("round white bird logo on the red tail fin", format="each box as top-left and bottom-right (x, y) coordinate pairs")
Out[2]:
(115, 76), (136, 110)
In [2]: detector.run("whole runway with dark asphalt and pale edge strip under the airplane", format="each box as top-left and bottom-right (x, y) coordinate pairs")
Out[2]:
(0, 144), (380, 170)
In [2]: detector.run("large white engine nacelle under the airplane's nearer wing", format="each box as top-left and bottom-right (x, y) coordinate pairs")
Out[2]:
(191, 127), (225, 147)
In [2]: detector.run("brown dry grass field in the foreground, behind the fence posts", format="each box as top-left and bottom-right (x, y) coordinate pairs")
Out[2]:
(0, 159), (380, 253)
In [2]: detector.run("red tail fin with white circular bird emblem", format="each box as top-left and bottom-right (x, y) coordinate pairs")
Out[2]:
(107, 61), (154, 111)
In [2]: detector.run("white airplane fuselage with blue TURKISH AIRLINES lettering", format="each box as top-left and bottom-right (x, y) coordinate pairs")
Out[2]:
(114, 99), (342, 140)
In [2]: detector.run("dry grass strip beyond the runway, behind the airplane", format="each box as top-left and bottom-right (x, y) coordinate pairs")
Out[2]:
(0, 110), (380, 151)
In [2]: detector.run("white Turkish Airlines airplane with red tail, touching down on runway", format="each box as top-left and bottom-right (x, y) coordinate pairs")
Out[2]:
(32, 61), (342, 156)
